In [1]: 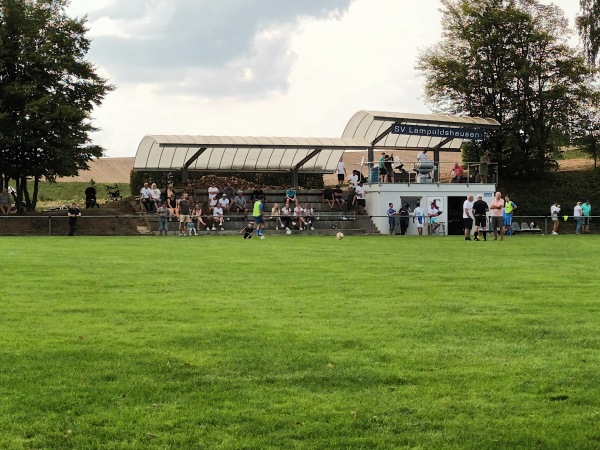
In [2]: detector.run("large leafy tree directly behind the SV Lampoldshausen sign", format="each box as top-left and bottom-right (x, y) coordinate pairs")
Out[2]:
(417, 0), (593, 174)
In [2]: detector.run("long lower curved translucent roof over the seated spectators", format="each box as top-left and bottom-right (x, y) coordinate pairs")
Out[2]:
(133, 135), (369, 173)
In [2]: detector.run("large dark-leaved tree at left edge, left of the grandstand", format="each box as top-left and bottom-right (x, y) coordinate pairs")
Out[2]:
(0, 0), (113, 209)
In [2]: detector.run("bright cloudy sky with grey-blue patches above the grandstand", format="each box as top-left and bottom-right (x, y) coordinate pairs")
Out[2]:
(68, 0), (579, 157)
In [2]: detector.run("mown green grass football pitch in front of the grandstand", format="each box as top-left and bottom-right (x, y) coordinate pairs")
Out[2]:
(0, 235), (600, 449)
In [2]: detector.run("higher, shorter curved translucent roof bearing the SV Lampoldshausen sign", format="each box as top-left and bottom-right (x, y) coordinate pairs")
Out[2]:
(342, 111), (500, 150)
